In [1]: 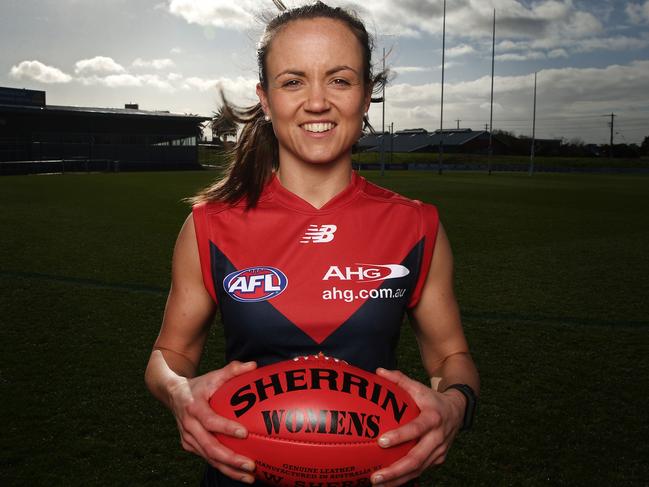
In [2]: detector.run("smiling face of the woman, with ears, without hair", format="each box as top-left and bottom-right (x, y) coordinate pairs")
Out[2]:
(257, 18), (371, 170)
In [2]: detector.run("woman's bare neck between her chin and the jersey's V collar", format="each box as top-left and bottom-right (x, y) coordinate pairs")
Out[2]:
(277, 163), (352, 209)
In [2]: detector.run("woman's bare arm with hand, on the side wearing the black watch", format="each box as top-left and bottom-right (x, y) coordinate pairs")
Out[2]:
(372, 225), (480, 487)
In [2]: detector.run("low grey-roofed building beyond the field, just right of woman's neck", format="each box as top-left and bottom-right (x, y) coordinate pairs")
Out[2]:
(358, 129), (488, 152)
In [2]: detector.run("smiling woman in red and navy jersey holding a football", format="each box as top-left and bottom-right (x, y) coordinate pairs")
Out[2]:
(146, 2), (479, 486)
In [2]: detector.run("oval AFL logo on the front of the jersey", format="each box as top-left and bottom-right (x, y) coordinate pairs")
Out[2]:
(223, 267), (288, 303)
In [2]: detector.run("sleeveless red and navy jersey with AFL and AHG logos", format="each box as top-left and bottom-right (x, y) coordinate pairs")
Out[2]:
(193, 173), (439, 371)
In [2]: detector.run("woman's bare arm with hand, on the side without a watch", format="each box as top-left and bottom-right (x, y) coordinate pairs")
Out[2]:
(145, 215), (256, 483)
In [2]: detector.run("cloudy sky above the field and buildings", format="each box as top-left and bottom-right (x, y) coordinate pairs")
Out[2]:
(0, 0), (649, 143)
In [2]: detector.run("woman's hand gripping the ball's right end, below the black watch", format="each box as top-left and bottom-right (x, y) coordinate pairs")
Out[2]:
(372, 369), (465, 487)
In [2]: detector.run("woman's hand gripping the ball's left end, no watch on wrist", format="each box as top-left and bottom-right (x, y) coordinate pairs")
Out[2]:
(169, 361), (257, 483)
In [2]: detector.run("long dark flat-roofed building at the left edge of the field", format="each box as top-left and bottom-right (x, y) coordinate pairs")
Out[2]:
(0, 87), (209, 174)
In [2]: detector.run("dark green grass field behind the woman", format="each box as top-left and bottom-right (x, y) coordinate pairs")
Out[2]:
(0, 172), (649, 487)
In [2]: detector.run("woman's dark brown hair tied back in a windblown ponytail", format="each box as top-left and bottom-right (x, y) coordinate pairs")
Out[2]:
(190, 0), (387, 208)
